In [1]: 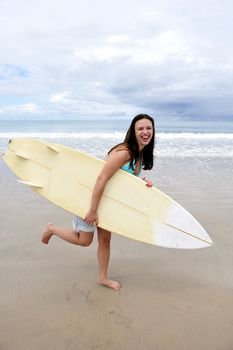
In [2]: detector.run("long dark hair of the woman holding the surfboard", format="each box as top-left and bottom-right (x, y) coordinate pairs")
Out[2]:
(108, 114), (155, 170)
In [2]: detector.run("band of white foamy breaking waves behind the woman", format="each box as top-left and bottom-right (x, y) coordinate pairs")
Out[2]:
(0, 131), (233, 158)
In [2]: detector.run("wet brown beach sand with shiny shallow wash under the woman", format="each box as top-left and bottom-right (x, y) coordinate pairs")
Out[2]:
(0, 159), (233, 350)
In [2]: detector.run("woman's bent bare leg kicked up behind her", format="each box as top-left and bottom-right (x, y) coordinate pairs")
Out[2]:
(42, 223), (94, 247)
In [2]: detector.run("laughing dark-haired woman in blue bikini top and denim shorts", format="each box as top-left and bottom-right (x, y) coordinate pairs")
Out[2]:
(42, 114), (155, 290)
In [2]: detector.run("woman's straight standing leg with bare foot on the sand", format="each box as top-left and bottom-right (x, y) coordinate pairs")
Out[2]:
(97, 227), (121, 290)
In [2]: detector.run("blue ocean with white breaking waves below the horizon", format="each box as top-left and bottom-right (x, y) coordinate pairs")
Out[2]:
(0, 119), (233, 159)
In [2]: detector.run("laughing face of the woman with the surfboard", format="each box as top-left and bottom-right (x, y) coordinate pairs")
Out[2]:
(135, 118), (154, 151)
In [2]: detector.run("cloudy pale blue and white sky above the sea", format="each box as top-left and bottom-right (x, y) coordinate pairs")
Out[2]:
(0, 0), (233, 120)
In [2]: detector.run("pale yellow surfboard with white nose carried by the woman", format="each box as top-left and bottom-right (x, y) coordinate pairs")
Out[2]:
(3, 138), (213, 249)
